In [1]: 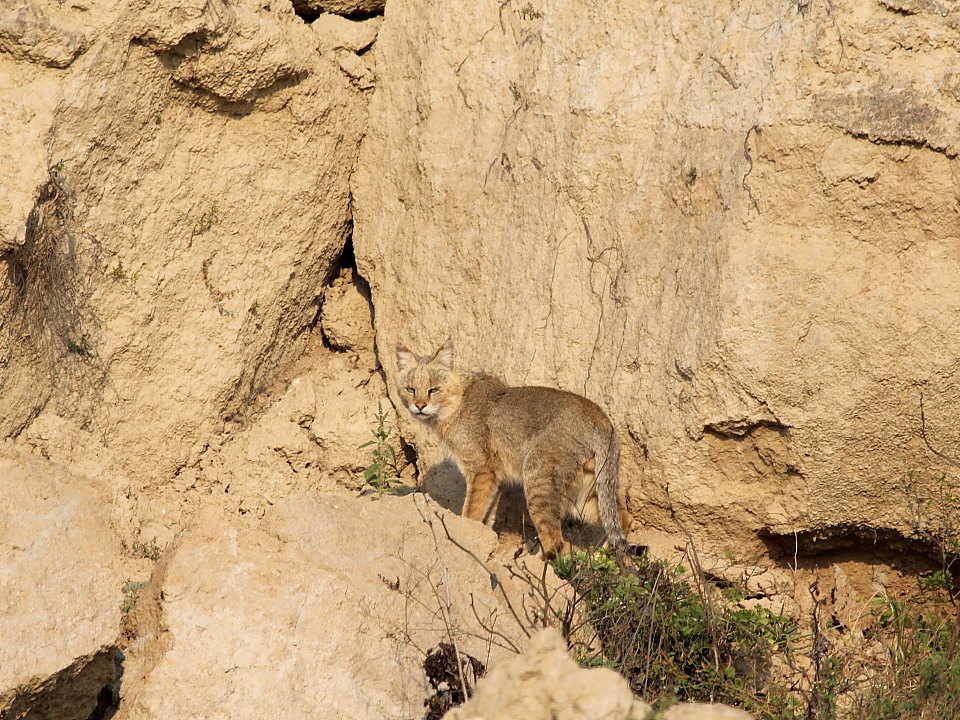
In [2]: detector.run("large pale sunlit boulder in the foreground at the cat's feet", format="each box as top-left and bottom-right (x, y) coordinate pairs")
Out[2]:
(116, 493), (540, 720)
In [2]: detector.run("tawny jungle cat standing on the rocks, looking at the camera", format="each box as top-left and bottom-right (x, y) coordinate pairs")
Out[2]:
(397, 340), (630, 559)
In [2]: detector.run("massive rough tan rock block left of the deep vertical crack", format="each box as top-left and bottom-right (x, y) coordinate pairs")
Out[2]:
(0, 0), (374, 498)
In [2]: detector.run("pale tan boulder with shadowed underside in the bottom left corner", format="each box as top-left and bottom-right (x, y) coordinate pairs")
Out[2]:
(0, 442), (131, 720)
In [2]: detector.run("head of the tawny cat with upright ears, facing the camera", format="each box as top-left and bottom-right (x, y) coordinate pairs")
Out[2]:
(397, 340), (461, 422)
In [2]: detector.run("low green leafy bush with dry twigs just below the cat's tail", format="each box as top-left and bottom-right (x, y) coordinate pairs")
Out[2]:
(555, 550), (799, 720)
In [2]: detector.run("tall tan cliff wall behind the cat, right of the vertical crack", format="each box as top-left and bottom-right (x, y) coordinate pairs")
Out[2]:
(353, 0), (960, 556)
